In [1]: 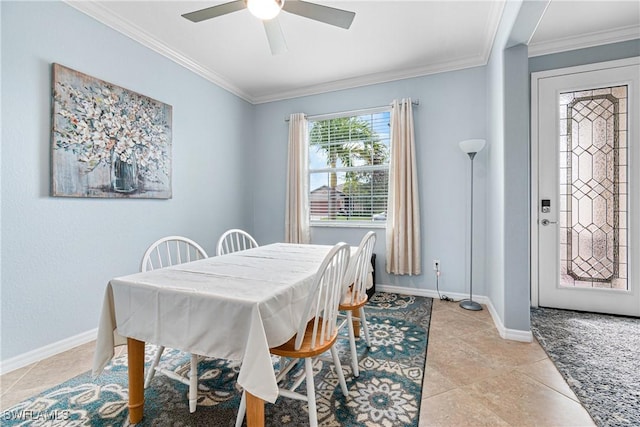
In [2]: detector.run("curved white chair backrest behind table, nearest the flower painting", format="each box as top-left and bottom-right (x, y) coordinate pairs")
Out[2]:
(140, 236), (207, 271)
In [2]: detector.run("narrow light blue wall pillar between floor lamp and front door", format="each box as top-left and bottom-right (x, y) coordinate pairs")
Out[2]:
(487, 1), (545, 335)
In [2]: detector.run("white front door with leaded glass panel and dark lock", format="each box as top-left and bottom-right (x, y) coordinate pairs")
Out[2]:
(531, 58), (640, 316)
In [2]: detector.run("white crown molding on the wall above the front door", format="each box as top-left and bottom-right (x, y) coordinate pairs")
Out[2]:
(529, 25), (640, 57)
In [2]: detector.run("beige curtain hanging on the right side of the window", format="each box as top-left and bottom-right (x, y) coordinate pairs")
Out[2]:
(387, 98), (421, 274)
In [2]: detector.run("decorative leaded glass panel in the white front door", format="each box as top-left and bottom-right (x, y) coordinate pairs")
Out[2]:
(558, 85), (628, 291)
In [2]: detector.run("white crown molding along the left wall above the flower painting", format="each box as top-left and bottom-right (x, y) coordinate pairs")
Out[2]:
(63, 0), (253, 103)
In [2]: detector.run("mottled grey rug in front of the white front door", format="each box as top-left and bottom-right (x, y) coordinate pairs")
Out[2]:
(531, 308), (640, 427)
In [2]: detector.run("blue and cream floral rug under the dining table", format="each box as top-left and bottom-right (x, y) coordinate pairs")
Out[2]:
(1, 292), (432, 427)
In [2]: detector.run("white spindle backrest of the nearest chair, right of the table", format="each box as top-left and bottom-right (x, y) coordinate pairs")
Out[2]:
(295, 242), (351, 350)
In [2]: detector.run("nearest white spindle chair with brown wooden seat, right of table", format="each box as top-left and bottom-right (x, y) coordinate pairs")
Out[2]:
(236, 243), (351, 427)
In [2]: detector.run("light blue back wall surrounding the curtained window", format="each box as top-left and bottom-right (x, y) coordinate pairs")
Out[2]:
(254, 67), (487, 294)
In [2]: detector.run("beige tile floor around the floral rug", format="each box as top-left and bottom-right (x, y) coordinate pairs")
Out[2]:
(0, 300), (595, 427)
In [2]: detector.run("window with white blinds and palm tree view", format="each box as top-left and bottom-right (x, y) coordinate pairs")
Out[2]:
(309, 108), (390, 225)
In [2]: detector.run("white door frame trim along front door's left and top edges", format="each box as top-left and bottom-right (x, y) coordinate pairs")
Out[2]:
(529, 56), (640, 307)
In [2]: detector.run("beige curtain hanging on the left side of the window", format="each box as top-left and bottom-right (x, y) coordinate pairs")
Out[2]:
(284, 113), (311, 243)
